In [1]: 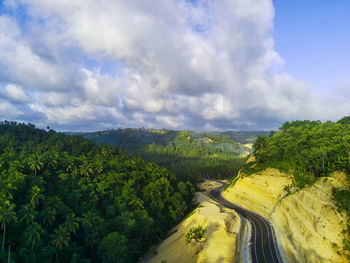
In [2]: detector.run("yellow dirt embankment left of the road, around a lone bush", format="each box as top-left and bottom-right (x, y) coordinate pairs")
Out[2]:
(142, 182), (242, 263)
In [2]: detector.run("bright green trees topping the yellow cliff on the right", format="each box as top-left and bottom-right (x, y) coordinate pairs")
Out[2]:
(243, 116), (350, 258)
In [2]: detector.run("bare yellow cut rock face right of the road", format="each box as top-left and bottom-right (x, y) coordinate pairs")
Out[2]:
(224, 169), (348, 263)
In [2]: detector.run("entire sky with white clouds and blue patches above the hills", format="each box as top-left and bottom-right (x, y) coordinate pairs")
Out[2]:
(0, 0), (350, 131)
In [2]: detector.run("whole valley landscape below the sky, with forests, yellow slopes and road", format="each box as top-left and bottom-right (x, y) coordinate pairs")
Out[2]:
(0, 117), (350, 263)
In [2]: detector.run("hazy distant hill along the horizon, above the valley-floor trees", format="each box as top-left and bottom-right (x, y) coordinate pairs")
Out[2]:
(80, 128), (249, 157)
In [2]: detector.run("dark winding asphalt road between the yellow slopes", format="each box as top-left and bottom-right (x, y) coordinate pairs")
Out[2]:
(210, 182), (283, 263)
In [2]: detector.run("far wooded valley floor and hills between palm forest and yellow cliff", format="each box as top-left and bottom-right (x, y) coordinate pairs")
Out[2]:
(80, 129), (251, 182)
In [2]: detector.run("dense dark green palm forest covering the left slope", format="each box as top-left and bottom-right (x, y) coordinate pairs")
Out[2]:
(0, 121), (194, 262)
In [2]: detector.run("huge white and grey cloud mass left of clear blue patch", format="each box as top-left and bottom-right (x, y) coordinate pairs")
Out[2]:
(0, 0), (349, 129)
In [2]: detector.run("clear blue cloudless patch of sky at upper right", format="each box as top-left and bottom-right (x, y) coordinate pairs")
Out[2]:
(274, 0), (350, 93)
